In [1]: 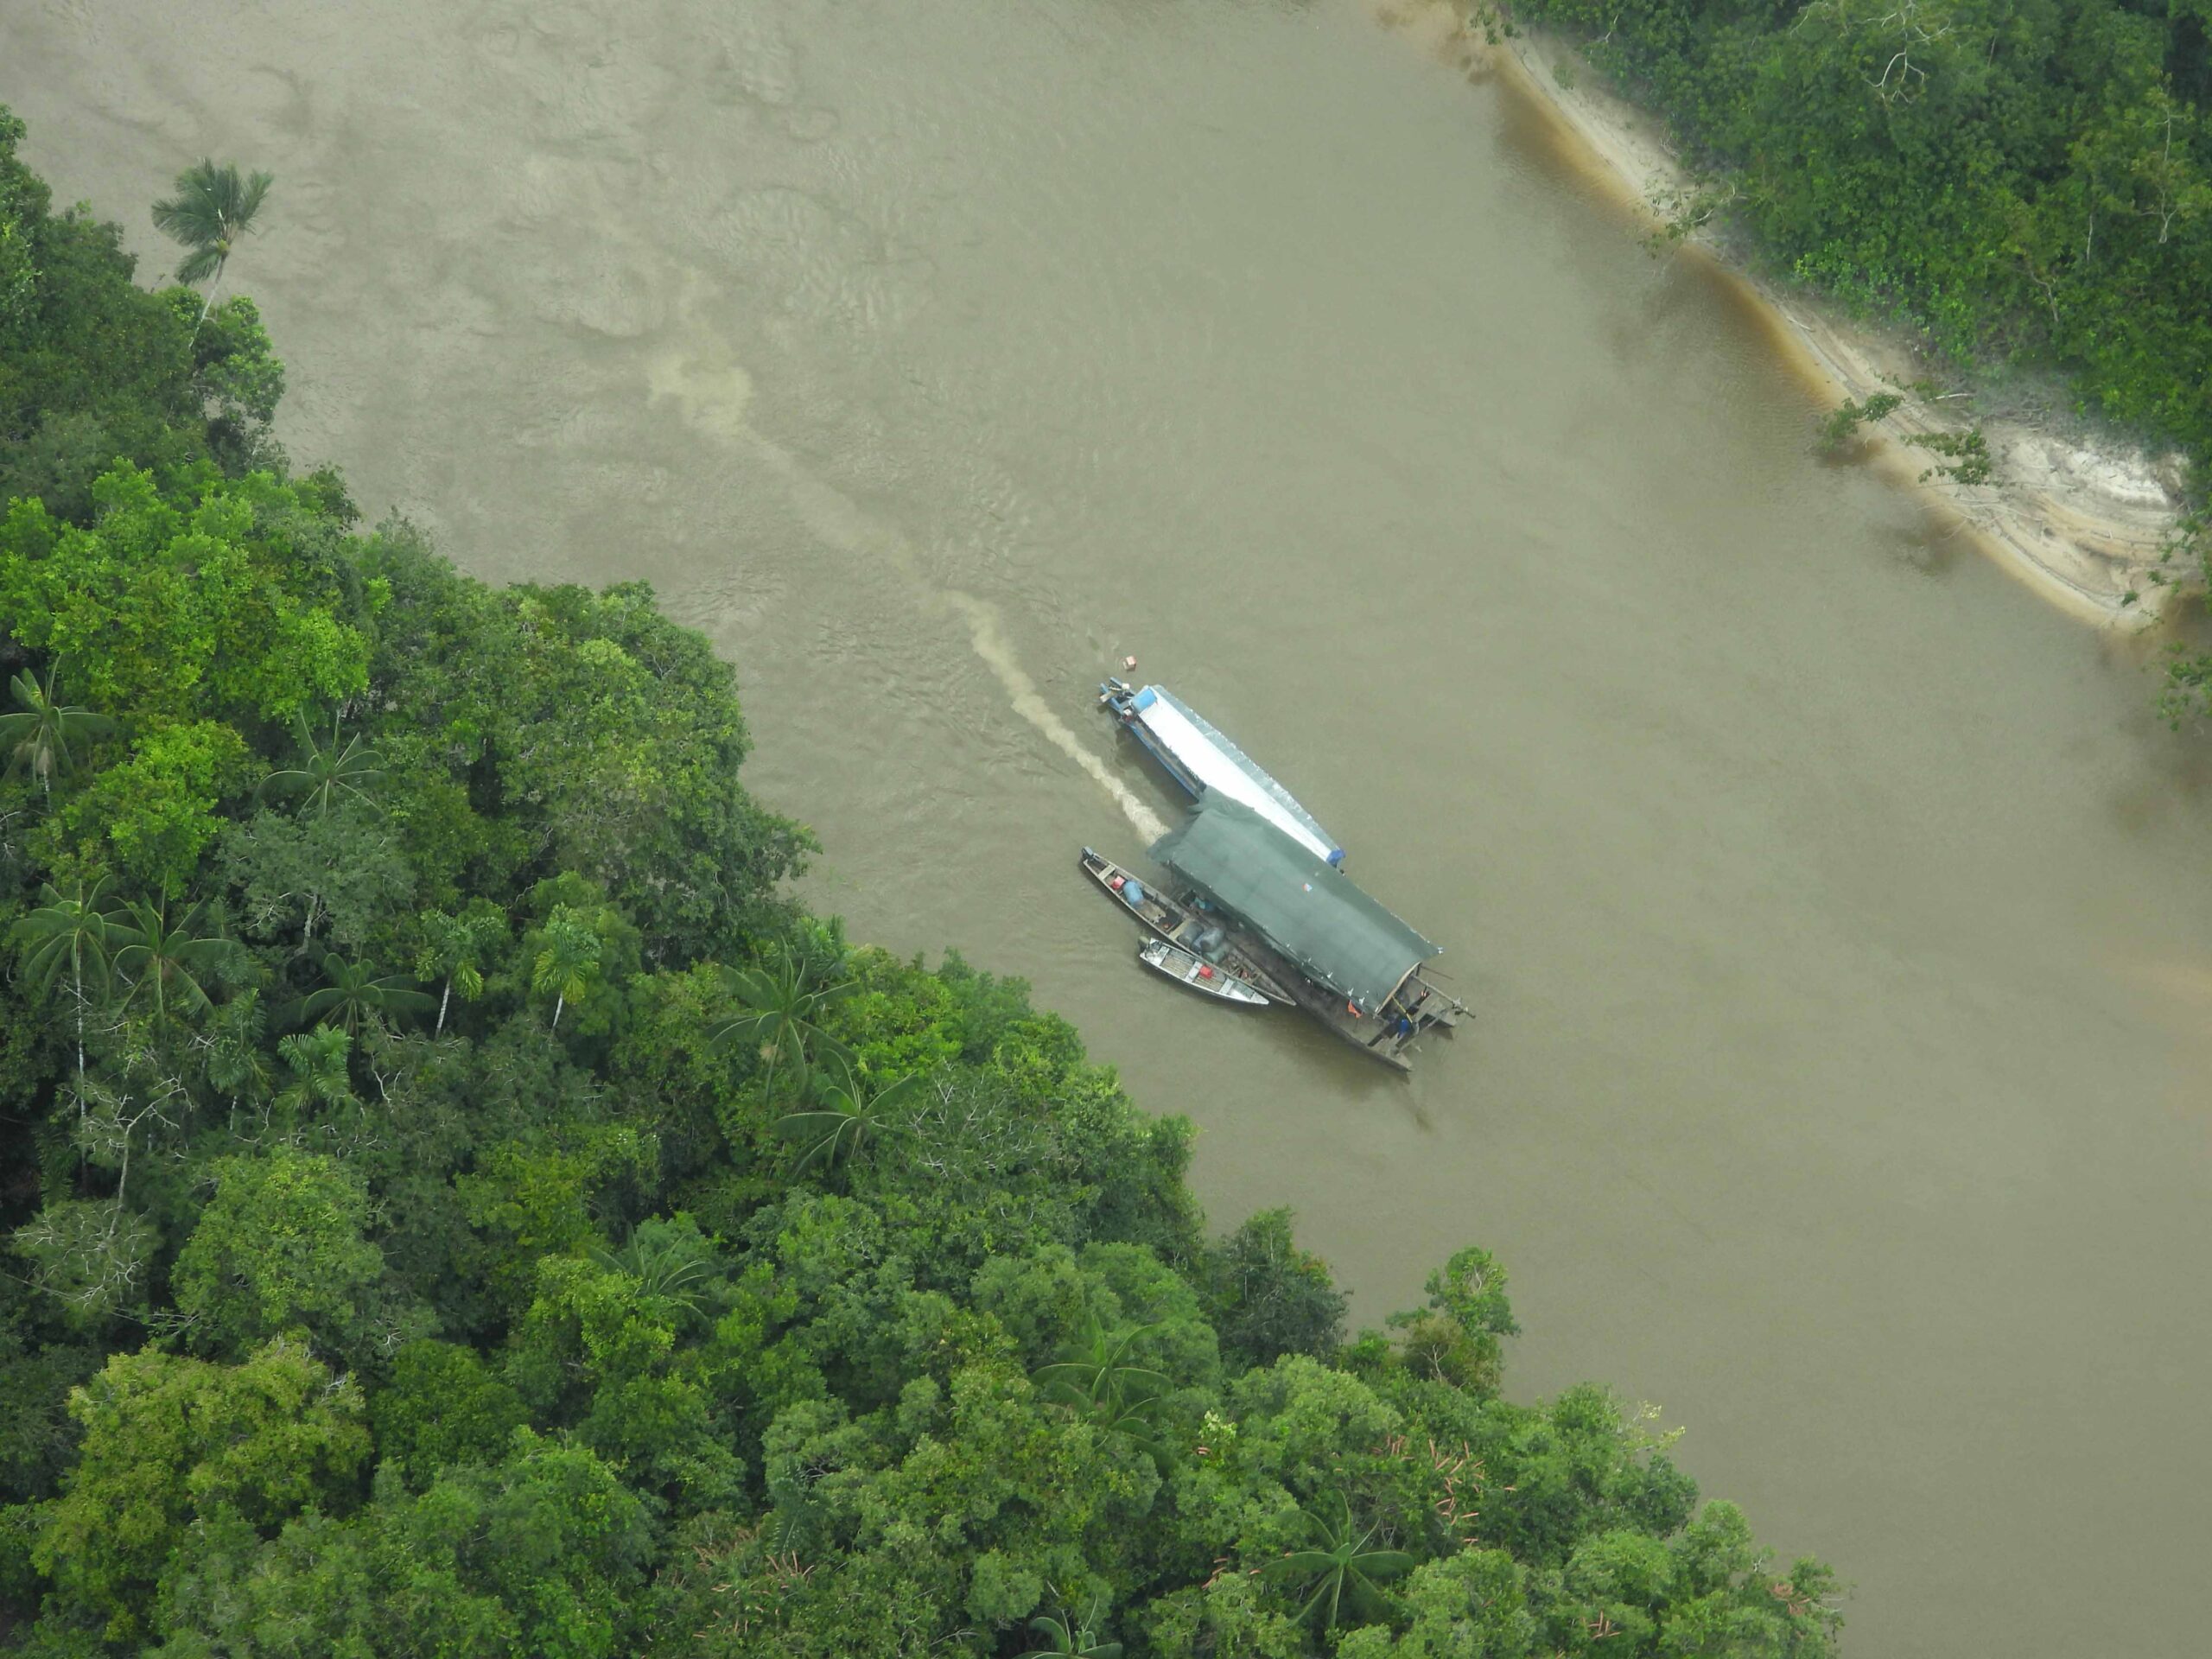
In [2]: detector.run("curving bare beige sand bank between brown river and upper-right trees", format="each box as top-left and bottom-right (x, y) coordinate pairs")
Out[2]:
(1370, 0), (2201, 628)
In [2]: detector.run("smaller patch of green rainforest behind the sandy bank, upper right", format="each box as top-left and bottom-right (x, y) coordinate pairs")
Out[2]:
(1509, 0), (2212, 467)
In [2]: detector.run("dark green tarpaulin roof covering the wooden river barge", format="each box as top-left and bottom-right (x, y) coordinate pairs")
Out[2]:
(1153, 790), (1438, 1011)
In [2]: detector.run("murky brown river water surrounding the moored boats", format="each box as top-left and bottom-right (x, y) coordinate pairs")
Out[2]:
(0, 0), (2212, 1656)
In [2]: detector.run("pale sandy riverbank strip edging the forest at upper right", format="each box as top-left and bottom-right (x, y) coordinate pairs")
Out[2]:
(1370, 0), (2185, 626)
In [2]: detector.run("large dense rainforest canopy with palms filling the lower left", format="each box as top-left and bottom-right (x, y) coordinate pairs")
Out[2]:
(0, 111), (1838, 1659)
